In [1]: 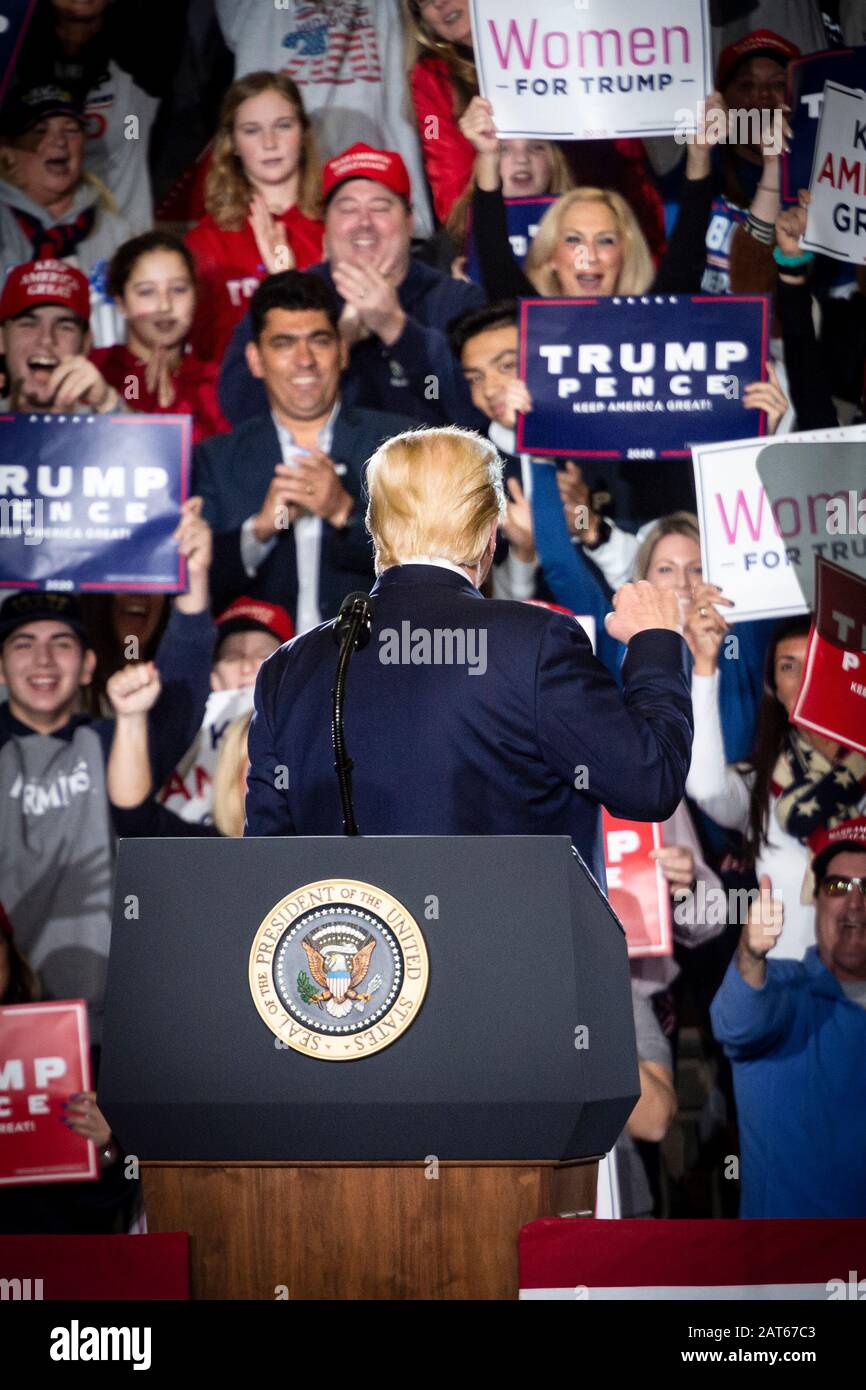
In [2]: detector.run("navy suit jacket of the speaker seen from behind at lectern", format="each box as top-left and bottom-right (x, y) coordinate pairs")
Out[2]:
(245, 564), (692, 884)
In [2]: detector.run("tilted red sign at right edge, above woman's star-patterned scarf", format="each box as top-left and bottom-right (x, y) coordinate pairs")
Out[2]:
(791, 627), (866, 753)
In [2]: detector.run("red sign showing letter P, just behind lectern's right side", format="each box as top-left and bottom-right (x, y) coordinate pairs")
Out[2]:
(602, 810), (673, 956)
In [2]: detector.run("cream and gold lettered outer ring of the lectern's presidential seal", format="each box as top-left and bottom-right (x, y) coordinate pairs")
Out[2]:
(247, 876), (430, 1062)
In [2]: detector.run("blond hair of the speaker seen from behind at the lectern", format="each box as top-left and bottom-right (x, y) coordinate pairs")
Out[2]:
(367, 425), (505, 574)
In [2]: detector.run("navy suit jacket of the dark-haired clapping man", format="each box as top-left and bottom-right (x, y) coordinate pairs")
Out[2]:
(193, 403), (416, 620)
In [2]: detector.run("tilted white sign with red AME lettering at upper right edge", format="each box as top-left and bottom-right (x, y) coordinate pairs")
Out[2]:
(801, 82), (866, 265)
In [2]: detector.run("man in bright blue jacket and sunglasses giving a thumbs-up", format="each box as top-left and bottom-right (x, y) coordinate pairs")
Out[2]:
(712, 816), (866, 1218)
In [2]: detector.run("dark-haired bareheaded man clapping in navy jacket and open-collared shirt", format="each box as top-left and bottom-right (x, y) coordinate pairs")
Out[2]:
(193, 271), (411, 632)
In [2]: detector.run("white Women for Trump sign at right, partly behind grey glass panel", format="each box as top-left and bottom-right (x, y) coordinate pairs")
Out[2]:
(692, 425), (866, 623)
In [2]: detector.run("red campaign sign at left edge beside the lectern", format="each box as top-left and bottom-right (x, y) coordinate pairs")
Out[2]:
(0, 999), (99, 1187)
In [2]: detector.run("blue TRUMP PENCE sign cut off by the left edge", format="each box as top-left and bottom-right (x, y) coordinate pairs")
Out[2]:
(0, 414), (192, 594)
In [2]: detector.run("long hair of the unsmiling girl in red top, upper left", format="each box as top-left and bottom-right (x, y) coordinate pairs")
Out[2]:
(204, 72), (321, 232)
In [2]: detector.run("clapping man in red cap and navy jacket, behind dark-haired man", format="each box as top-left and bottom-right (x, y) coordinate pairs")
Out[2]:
(220, 145), (484, 428)
